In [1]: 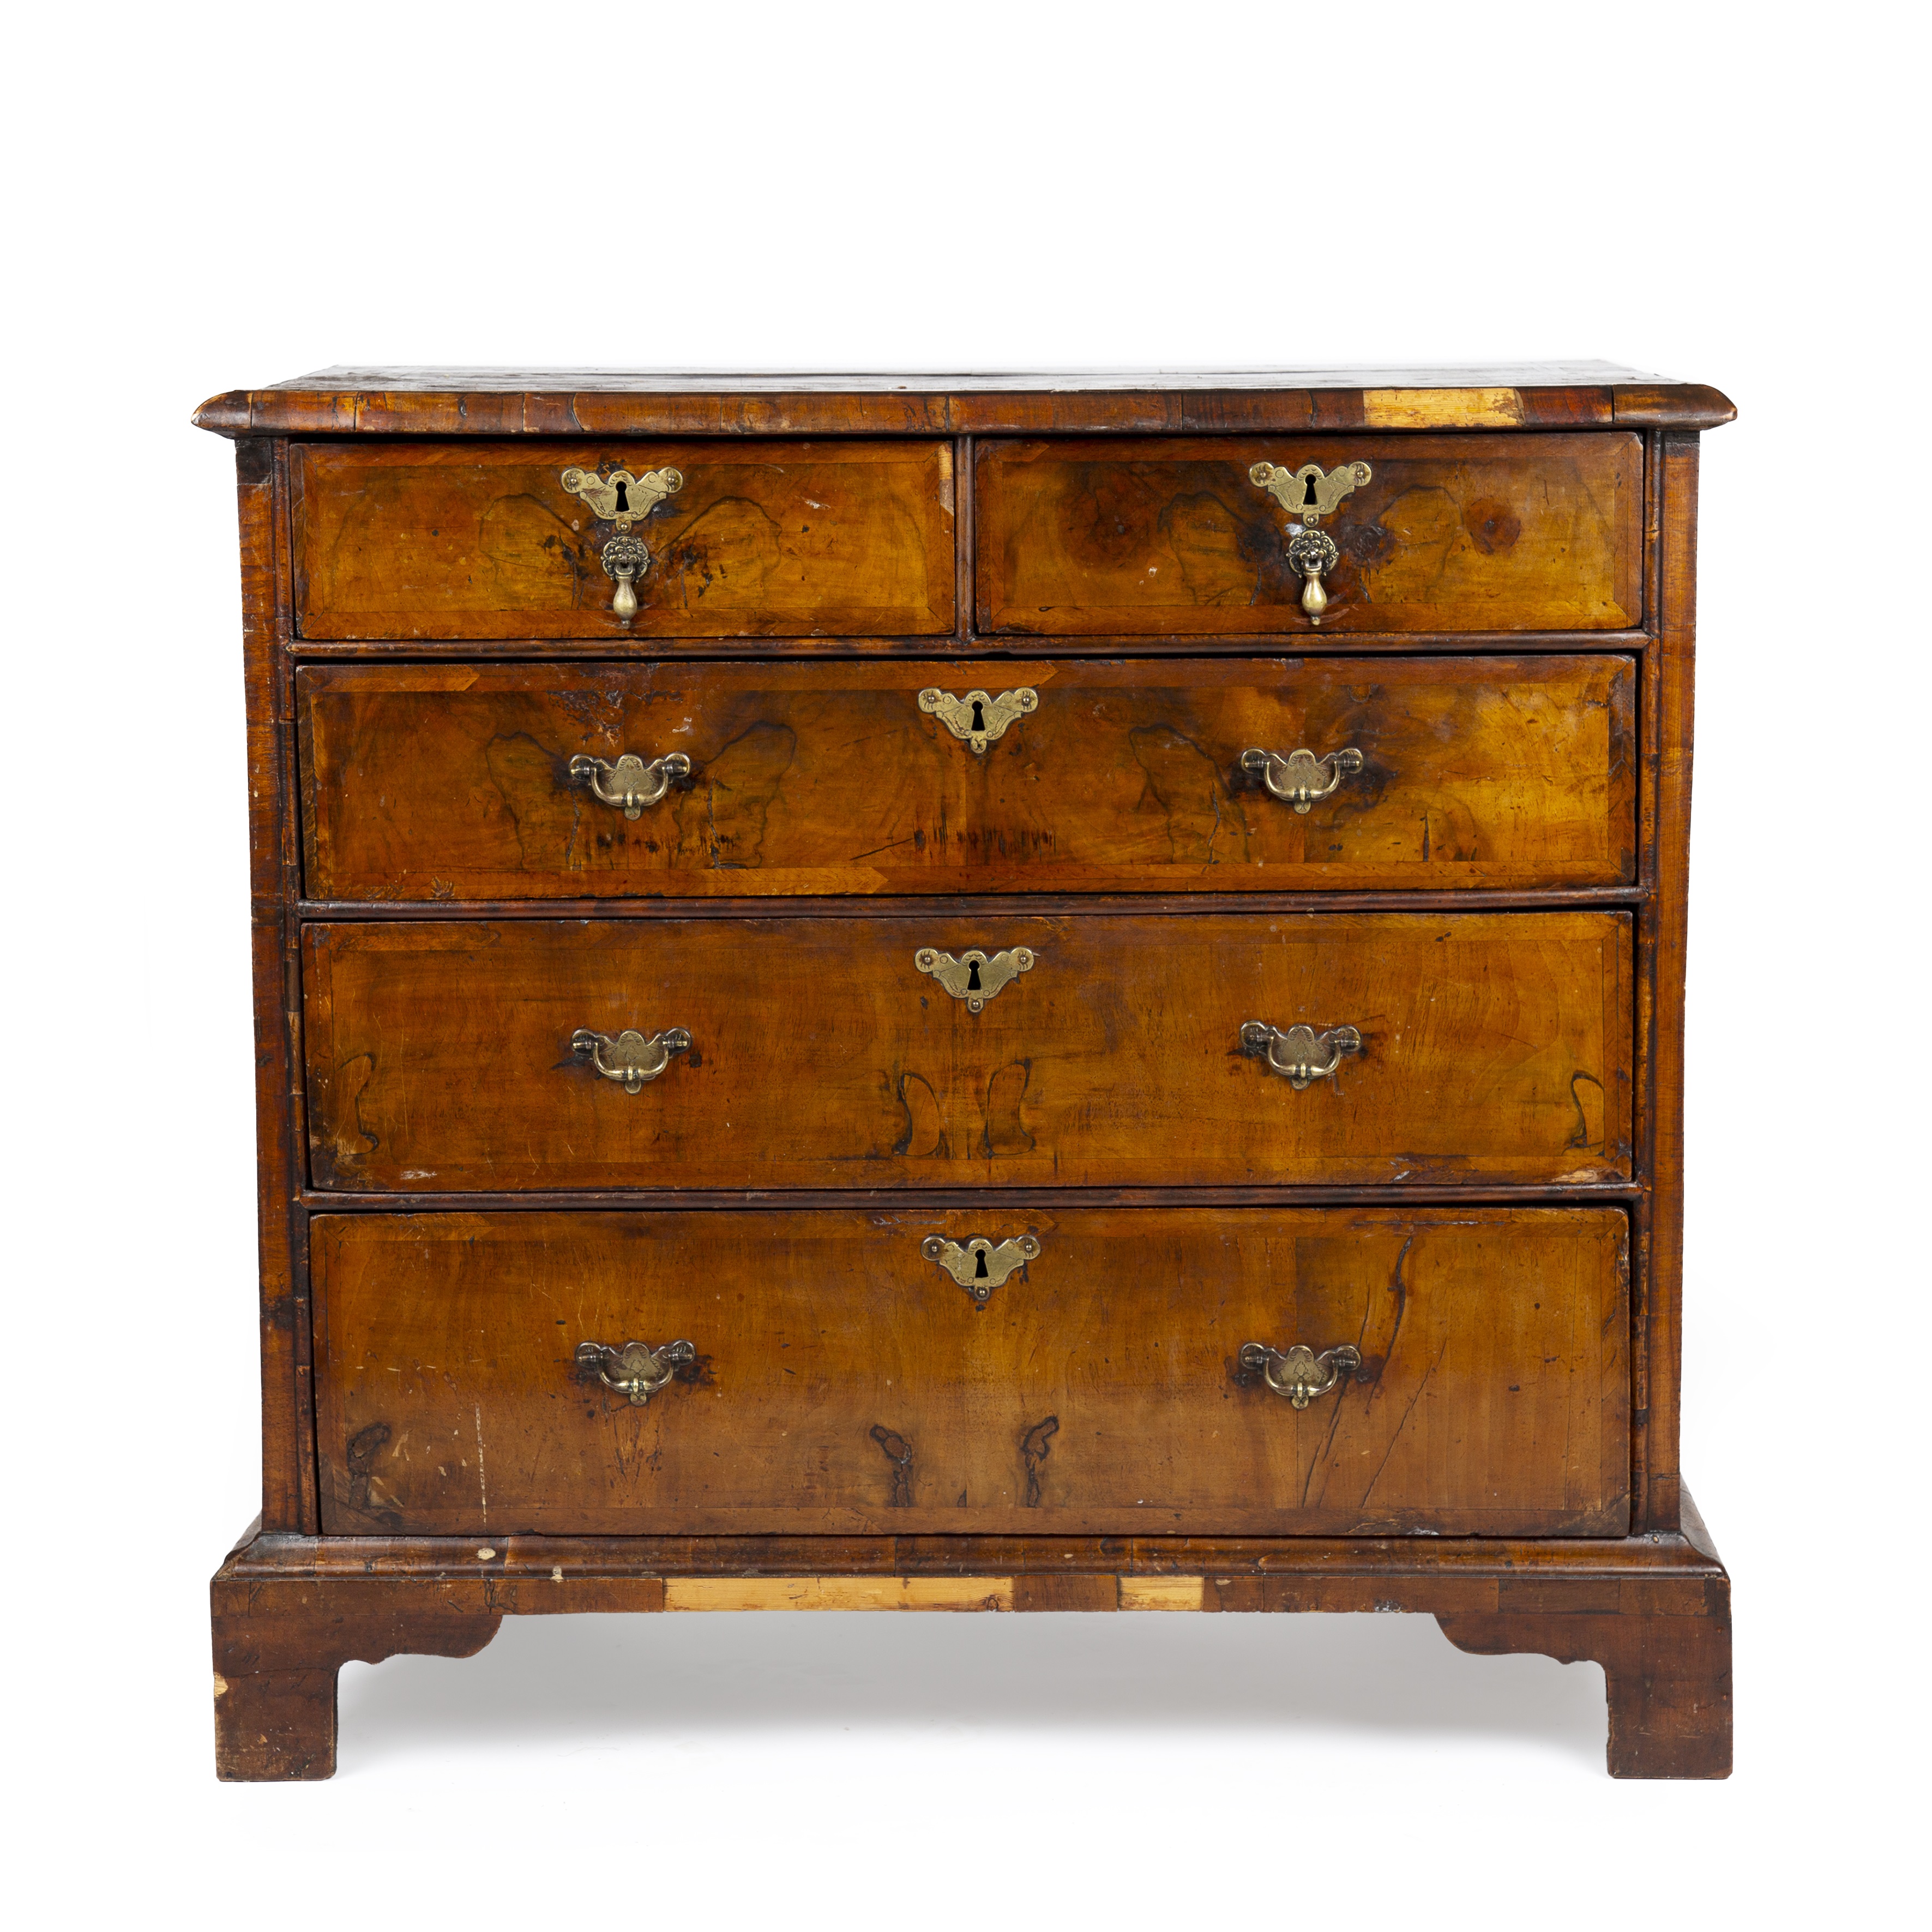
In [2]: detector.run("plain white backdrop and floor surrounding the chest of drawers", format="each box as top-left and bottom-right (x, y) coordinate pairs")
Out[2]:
(0, 0), (1932, 1928)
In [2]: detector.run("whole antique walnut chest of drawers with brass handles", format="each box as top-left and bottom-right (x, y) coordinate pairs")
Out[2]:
(197, 363), (1731, 1778)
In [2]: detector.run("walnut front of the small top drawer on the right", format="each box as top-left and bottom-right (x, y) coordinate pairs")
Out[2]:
(976, 431), (1644, 637)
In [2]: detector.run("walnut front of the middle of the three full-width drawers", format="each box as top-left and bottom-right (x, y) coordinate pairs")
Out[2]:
(303, 912), (1630, 1192)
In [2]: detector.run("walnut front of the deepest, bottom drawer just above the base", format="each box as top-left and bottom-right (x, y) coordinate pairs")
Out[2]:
(311, 1207), (1629, 1540)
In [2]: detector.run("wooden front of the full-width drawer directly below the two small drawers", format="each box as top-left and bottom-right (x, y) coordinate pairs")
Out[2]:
(298, 655), (1636, 900)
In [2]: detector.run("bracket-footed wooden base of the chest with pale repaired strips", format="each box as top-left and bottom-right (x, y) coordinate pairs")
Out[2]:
(209, 1497), (1731, 1779)
